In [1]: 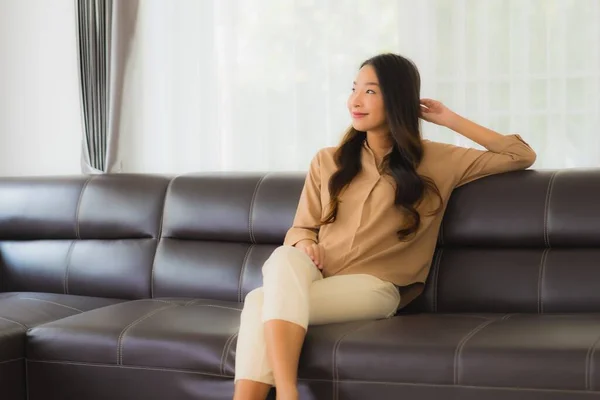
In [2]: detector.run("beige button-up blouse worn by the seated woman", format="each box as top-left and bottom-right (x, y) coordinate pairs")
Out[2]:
(284, 135), (536, 307)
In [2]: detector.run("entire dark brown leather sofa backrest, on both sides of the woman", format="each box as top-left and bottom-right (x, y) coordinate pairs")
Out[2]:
(0, 170), (600, 313)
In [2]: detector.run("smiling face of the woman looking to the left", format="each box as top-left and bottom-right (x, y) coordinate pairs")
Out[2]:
(348, 65), (388, 132)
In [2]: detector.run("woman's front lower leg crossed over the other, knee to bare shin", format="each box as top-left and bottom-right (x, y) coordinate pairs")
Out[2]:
(263, 246), (323, 400)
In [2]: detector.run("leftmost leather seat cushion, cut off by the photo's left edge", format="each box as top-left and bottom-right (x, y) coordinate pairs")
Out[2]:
(0, 292), (122, 362)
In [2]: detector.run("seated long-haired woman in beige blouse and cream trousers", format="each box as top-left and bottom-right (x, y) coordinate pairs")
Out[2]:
(234, 54), (536, 400)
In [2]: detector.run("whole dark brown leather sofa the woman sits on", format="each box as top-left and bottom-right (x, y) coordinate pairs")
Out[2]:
(0, 170), (600, 400)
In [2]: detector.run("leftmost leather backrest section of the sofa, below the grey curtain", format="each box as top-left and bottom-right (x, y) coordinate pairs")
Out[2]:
(0, 175), (170, 299)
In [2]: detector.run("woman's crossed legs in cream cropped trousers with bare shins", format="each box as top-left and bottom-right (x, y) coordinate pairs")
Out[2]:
(235, 248), (400, 400)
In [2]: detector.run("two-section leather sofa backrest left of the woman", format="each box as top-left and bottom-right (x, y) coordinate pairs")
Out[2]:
(0, 173), (304, 301)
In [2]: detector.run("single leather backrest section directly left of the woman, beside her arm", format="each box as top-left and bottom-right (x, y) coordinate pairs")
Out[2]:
(152, 174), (303, 302)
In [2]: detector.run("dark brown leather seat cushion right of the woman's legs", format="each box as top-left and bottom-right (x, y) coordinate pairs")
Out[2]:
(322, 314), (600, 391)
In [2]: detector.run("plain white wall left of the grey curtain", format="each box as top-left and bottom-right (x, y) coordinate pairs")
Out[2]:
(0, 0), (81, 176)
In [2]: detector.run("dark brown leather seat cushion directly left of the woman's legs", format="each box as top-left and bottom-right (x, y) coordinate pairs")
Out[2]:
(27, 299), (242, 376)
